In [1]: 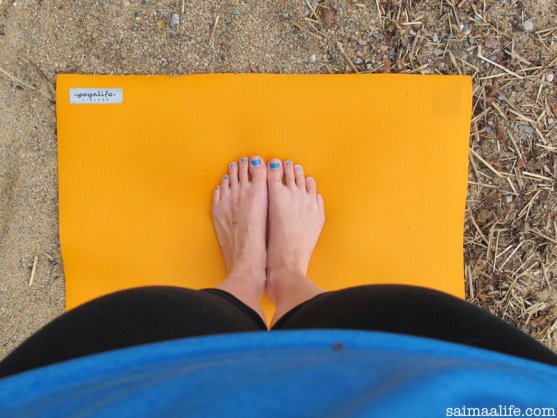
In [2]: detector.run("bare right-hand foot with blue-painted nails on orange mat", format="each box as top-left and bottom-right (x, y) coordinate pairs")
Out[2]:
(267, 159), (325, 326)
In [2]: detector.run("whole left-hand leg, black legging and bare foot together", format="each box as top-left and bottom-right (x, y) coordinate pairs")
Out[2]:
(0, 156), (278, 376)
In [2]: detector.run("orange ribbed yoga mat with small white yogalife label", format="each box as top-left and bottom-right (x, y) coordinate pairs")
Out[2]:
(56, 74), (472, 321)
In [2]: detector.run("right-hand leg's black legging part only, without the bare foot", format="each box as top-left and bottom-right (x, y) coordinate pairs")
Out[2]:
(272, 285), (557, 365)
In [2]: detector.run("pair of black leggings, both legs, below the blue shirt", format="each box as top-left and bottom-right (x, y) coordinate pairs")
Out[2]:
(0, 285), (557, 377)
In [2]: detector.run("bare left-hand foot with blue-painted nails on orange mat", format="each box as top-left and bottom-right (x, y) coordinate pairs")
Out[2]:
(211, 156), (267, 321)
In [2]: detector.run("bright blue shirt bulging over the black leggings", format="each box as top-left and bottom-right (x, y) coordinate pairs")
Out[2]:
(0, 330), (557, 418)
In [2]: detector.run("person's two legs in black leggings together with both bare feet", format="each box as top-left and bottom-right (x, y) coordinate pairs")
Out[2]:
(0, 155), (557, 377)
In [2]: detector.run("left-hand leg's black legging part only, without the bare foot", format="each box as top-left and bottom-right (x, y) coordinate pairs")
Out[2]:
(0, 286), (267, 377)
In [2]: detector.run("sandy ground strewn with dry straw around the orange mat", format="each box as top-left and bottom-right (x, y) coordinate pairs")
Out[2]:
(0, 0), (557, 358)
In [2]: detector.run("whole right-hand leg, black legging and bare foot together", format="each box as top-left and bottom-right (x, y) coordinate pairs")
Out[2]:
(267, 159), (557, 364)
